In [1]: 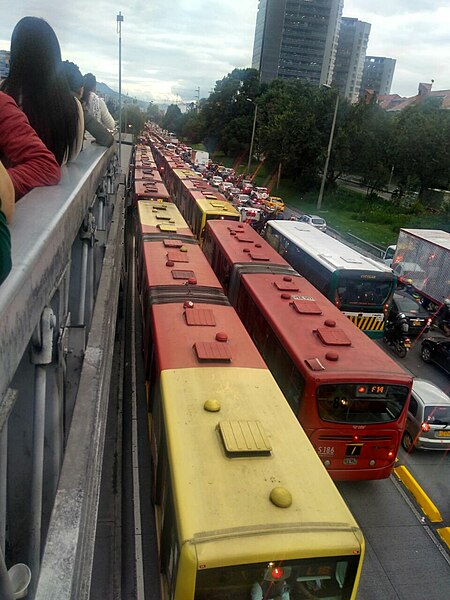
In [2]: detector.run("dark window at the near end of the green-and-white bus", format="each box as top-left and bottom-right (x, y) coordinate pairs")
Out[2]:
(336, 277), (392, 306)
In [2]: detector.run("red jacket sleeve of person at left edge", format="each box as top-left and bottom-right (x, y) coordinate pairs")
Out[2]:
(0, 92), (61, 200)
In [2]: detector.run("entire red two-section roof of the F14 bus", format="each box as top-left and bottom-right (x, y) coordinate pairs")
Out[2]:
(207, 221), (411, 383)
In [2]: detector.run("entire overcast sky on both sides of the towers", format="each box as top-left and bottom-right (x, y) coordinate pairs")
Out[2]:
(0, 0), (450, 103)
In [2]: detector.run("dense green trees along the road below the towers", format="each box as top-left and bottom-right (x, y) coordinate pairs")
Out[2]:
(174, 64), (450, 230)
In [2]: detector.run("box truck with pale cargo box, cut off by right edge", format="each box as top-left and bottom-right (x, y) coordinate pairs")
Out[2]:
(391, 229), (450, 305)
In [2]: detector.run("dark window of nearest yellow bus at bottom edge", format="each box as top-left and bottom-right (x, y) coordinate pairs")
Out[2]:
(194, 556), (359, 600)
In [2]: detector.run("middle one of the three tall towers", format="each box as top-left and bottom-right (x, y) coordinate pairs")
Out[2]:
(333, 17), (370, 102)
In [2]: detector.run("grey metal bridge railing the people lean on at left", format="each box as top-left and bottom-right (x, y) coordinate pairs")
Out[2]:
(0, 145), (124, 600)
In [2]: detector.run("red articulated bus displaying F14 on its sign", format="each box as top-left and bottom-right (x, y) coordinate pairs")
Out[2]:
(203, 221), (412, 480)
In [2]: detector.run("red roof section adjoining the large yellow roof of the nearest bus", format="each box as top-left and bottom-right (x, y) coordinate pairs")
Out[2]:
(152, 303), (267, 372)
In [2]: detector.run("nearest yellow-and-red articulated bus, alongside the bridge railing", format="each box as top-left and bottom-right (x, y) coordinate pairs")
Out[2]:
(131, 177), (364, 600)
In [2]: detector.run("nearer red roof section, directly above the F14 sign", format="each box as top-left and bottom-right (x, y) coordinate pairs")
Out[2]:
(242, 273), (411, 383)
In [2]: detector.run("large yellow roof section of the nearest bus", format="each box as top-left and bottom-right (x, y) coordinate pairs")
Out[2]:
(161, 367), (364, 568)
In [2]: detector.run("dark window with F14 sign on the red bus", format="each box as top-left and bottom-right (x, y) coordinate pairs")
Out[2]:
(317, 383), (408, 425)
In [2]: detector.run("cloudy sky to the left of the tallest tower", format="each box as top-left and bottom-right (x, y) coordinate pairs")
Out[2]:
(0, 0), (257, 102)
